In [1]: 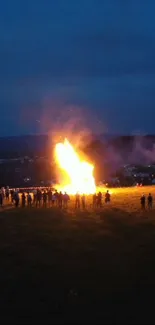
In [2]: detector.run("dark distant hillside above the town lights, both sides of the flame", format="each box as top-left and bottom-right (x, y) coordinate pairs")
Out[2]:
(0, 134), (155, 163)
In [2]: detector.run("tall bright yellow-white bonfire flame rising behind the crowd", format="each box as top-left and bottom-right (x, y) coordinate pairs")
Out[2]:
(55, 139), (96, 194)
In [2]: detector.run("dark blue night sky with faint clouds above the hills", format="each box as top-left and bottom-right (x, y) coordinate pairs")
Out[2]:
(0, 0), (155, 135)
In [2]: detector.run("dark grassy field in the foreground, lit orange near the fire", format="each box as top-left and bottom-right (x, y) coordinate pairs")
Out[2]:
(0, 187), (155, 324)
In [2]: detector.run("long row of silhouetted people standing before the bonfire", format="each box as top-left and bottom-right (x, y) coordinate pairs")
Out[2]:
(0, 187), (111, 209)
